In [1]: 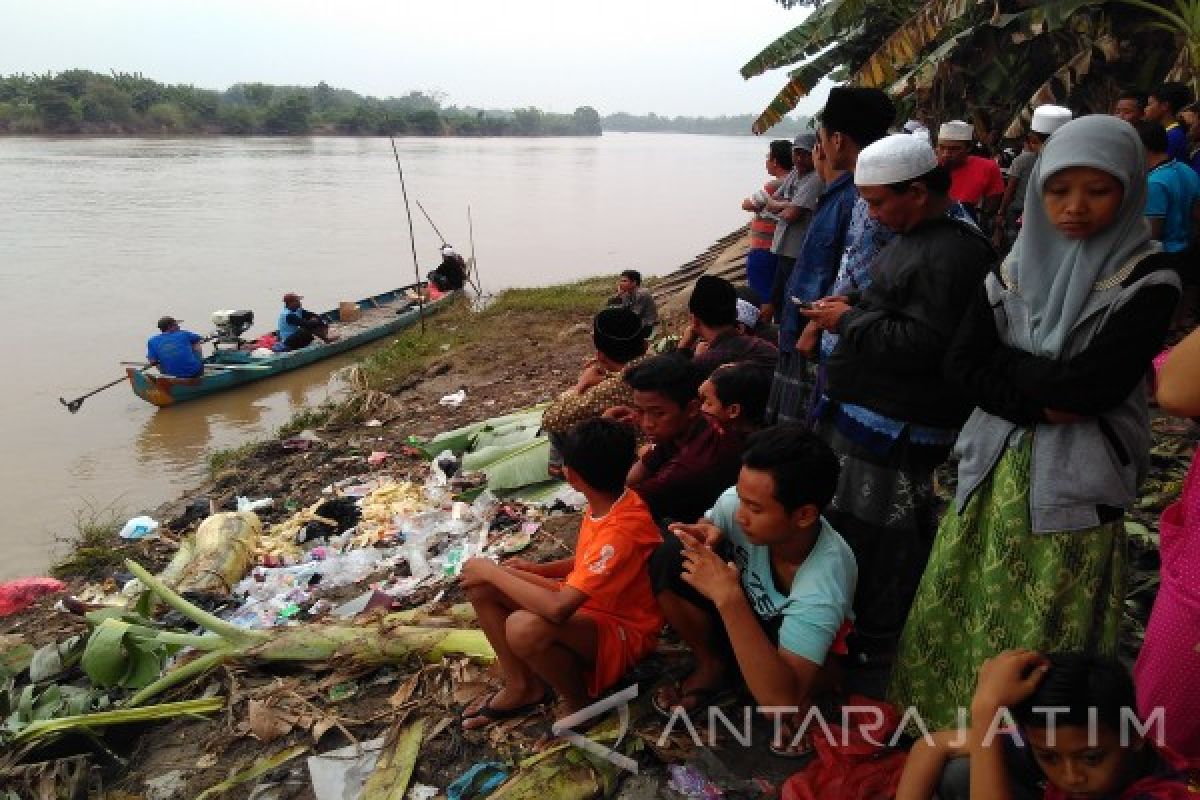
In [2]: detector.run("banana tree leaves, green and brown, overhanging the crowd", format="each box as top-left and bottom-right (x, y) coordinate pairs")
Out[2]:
(742, 0), (1185, 133)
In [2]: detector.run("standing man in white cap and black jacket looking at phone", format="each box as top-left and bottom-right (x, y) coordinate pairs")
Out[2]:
(800, 133), (992, 663)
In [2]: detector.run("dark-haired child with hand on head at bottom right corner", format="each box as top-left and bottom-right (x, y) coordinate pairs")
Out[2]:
(896, 650), (1195, 800)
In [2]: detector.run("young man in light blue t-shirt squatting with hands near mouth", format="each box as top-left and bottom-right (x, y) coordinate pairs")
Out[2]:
(650, 425), (858, 756)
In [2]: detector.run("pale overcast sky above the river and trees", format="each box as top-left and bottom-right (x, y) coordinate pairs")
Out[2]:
(0, 0), (827, 116)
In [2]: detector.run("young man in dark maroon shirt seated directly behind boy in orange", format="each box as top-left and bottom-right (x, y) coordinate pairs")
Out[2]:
(610, 354), (742, 522)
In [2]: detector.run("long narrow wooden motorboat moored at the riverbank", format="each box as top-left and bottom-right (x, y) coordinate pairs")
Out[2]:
(125, 285), (458, 407)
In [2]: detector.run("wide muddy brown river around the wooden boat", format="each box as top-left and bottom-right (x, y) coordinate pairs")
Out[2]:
(0, 133), (767, 579)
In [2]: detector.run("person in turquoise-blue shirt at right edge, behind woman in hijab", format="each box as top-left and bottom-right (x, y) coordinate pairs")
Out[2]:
(1136, 121), (1200, 253)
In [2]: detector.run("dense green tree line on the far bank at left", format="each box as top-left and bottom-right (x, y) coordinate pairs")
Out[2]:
(0, 70), (600, 137)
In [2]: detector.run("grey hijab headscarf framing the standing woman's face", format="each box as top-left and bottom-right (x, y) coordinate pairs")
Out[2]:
(1004, 115), (1153, 357)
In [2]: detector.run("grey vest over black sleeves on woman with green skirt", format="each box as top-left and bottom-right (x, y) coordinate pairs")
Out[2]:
(954, 258), (1180, 533)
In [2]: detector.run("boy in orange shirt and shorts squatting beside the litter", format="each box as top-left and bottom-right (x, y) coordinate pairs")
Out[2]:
(462, 419), (662, 729)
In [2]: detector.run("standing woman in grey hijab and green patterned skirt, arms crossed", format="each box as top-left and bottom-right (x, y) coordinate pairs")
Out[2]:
(892, 116), (1180, 729)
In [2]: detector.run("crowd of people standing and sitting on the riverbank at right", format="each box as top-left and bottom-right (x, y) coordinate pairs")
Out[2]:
(463, 84), (1200, 800)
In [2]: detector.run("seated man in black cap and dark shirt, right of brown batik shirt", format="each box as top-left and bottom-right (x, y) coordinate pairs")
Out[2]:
(679, 275), (779, 380)
